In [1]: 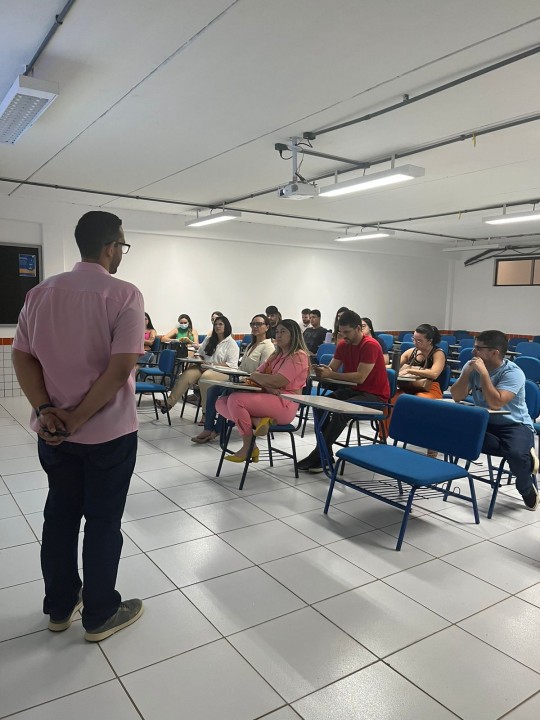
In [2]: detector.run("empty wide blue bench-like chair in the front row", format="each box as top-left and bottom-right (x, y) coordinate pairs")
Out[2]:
(324, 395), (488, 550)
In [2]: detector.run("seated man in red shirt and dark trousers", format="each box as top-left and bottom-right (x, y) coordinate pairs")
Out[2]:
(298, 310), (390, 473)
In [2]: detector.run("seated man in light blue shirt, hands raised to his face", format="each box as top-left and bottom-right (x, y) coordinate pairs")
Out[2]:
(451, 330), (540, 510)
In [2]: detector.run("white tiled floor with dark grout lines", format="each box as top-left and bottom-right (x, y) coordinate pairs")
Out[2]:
(0, 398), (540, 720)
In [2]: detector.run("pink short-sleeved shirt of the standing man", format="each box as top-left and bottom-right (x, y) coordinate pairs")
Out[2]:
(13, 262), (144, 444)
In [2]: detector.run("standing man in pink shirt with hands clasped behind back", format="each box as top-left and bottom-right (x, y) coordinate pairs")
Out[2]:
(13, 211), (144, 642)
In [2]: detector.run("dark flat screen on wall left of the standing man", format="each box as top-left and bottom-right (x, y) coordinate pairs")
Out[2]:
(0, 243), (41, 325)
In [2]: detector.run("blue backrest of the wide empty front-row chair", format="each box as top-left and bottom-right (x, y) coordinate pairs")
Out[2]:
(389, 394), (489, 460)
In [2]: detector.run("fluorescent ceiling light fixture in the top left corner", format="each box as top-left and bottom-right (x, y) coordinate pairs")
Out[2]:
(0, 75), (58, 145)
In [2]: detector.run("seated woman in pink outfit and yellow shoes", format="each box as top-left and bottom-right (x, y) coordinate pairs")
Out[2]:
(216, 320), (309, 462)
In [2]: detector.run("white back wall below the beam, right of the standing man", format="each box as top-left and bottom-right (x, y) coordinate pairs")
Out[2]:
(108, 234), (446, 333)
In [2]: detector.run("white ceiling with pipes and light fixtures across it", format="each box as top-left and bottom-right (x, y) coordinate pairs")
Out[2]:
(0, 0), (540, 249)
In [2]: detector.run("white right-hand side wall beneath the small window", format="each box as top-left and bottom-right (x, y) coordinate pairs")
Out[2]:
(450, 259), (540, 335)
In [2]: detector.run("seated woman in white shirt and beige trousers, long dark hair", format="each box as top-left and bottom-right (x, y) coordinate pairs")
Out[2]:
(156, 315), (240, 413)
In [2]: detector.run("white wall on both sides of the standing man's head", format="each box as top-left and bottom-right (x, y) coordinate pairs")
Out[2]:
(0, 198), (449, 337)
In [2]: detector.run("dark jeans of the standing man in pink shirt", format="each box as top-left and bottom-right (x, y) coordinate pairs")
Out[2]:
(38, 432), (137, 629)
